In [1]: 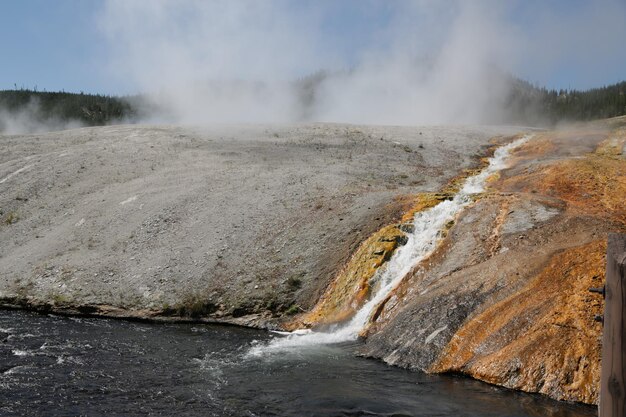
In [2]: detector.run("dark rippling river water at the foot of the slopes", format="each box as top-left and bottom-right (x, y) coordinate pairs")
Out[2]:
(0, 310), (597, 417)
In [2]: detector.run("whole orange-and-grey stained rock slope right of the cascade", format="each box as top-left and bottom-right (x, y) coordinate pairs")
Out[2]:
(362, 125), (626, 403)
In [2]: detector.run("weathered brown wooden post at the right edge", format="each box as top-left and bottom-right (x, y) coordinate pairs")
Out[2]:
(599, 233), (626, 417)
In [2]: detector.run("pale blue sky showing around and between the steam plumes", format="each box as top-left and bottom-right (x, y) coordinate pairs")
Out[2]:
(0, 0), (626, 94)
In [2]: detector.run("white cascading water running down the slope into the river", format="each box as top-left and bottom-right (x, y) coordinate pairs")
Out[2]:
(249, 136), (529, 356)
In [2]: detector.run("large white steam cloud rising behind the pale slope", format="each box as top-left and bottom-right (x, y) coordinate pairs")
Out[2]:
(99, 0), (626, 124)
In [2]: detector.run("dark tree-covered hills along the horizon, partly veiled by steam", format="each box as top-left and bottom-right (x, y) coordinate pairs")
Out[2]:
(0, 73), (626, 133)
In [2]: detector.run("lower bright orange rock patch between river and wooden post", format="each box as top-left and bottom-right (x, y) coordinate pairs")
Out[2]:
(429, 240), (606, 403)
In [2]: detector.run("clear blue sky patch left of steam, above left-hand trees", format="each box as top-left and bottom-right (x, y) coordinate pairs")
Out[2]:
(0, 0), (108, 92)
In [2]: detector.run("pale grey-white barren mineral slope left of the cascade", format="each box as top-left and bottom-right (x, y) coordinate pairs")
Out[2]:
(0, 124), (520, 325)
